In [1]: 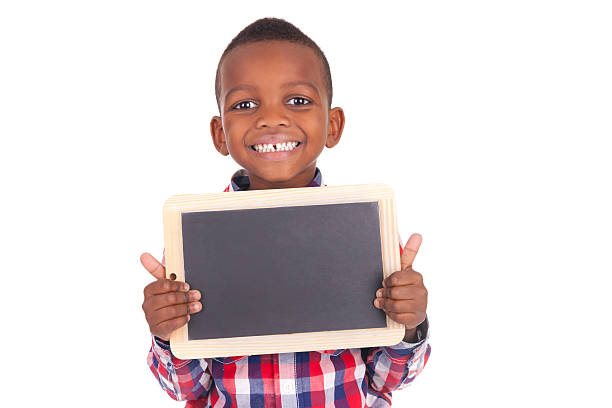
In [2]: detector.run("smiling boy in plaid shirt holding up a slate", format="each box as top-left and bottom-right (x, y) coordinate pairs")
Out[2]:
(141, 19), (430, 407)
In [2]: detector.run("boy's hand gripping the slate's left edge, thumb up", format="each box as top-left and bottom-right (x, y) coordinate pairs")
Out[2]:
(140, 252), (202, 341)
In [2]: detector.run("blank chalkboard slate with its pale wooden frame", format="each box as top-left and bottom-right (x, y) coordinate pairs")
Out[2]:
(164, 184), (404, 358)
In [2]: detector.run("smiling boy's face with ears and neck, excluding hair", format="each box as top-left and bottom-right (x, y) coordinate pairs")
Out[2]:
(211, 41), (344, 190)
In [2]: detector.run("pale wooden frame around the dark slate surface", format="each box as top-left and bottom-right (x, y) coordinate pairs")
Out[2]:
(163, 184), (405, 359)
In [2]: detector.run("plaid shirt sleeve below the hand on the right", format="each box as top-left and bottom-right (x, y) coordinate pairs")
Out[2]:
(363, 318), (431, 400)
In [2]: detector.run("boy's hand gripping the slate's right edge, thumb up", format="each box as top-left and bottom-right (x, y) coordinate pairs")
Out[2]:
(374, 234), (427, 338)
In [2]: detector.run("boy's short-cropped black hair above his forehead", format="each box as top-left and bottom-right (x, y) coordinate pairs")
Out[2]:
(215, 17), (333, 107)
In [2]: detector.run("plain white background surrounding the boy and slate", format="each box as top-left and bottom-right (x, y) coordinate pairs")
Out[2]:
(0, 0), (612, 407)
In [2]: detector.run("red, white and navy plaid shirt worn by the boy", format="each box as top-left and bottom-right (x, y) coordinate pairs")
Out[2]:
(147, 168), (431, 408)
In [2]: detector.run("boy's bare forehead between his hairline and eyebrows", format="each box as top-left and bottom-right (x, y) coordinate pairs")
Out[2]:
(219, 41), (325, 99)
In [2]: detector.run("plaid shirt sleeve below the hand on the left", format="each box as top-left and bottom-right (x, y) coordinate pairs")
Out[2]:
(147, 337), (213, 401)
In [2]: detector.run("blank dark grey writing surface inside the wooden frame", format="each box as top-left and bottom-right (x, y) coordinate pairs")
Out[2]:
(181, 202), (387, 340)
